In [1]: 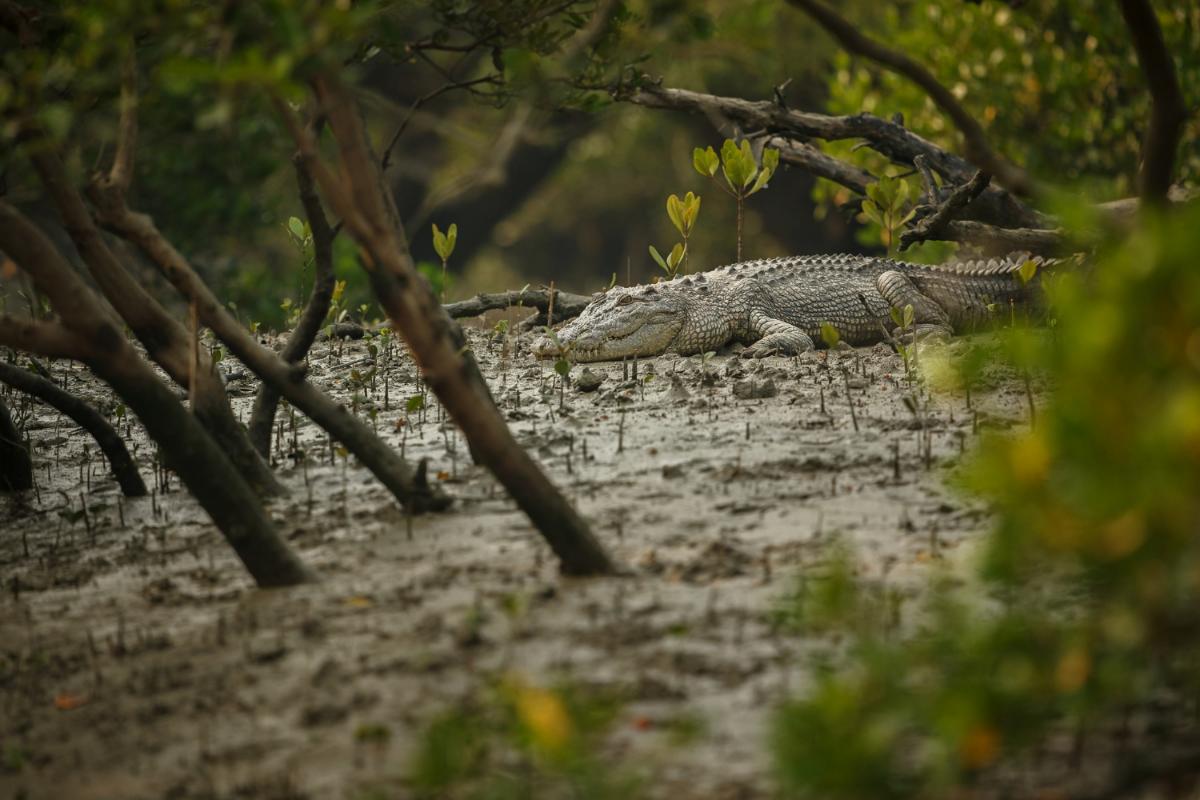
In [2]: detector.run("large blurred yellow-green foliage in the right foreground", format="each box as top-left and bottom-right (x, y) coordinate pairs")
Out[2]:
(774, 207), (1200, 798)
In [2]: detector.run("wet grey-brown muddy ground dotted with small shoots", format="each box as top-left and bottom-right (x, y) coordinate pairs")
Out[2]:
(0, 329), (1028, 799)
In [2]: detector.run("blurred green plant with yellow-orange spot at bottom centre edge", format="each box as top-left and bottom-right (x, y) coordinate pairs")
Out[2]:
(409, 676), (641, 800)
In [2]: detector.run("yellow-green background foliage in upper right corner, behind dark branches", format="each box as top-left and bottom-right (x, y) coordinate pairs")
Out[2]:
(818, 0), (1200, 217)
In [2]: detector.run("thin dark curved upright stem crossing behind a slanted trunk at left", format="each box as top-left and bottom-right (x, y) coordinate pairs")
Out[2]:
(250, 156), (335, 458)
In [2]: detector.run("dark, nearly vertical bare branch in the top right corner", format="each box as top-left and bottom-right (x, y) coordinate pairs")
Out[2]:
(1121, 0), (1188, 206)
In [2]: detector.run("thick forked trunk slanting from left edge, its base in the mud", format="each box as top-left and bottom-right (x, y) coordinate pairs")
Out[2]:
(0, 200), (313, 587)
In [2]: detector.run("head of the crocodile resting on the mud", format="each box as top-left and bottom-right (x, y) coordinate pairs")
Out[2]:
(534, 284), (688, 361)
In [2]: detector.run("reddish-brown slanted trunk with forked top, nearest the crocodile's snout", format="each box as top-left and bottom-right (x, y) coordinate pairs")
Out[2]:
(278, 76), (616, 575)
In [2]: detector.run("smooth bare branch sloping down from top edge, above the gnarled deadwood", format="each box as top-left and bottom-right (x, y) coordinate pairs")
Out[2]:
(787, 0), (1036, 194)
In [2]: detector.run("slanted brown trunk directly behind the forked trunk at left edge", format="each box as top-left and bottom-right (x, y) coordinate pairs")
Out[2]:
(31, 140), (287, 494)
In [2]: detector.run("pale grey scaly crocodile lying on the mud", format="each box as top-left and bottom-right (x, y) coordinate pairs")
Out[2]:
(534, 254), (1056, 361)
